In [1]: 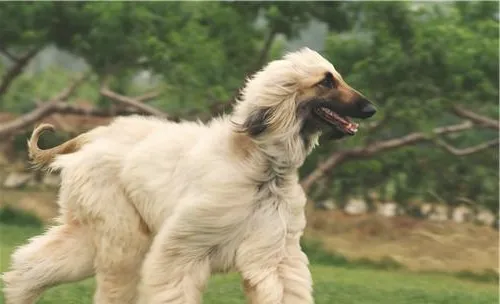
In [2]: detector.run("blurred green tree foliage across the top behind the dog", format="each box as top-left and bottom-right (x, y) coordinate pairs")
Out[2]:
(0, 1), (499, 210)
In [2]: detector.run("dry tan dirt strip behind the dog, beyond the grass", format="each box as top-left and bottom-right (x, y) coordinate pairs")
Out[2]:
(0, 189), (499, 272)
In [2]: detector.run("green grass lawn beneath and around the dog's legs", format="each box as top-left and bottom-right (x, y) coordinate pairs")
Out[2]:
(0, 224), (498, 304)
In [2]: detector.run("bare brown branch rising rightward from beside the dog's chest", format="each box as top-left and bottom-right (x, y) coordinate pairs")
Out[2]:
(301, 121), (474, 192)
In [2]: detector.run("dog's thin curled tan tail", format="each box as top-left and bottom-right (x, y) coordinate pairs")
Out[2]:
(28, 123), (86, 169)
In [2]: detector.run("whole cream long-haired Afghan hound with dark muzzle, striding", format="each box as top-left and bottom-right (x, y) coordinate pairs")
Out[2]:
(3, 48), (376, 304)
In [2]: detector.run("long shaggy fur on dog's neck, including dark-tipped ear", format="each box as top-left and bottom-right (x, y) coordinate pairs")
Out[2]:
(229, 69), (318, 189)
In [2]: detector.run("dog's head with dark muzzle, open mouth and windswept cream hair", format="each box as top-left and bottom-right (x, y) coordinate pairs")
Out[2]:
(235, 48), (376, 145)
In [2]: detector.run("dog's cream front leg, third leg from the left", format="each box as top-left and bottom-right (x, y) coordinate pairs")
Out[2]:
(138, 216), (210, 304)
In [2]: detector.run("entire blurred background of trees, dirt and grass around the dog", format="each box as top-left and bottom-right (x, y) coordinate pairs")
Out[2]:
(0, 1), (499, 303)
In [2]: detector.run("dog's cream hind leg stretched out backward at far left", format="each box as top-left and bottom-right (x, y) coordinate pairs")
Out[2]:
(2, 223), (94, 304)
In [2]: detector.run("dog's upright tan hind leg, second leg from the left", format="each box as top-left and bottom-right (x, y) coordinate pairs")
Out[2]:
(93, 197), (151, 304)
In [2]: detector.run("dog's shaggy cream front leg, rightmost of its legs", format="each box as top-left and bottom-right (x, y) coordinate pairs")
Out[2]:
(237, 195), (314, 304)
